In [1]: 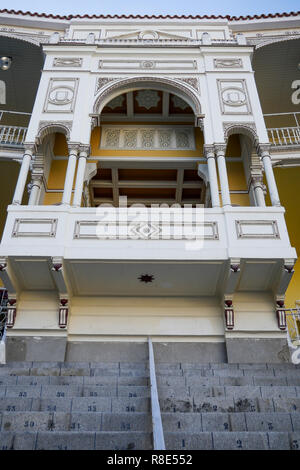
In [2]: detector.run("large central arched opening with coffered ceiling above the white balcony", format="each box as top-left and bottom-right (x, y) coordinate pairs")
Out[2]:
(89, 77), (206, 206)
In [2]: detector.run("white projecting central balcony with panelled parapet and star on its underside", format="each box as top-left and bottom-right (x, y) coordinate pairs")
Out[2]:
(0, 205), (296, 296)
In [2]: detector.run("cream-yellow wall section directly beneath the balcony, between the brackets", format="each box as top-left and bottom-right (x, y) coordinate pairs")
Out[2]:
(68, 297), (224, 338)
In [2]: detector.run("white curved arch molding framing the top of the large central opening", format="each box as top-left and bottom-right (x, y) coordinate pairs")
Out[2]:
(93, 76), (203, 117)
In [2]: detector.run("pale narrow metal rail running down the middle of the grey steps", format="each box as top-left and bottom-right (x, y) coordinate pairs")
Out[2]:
(148, 337), (166, 450)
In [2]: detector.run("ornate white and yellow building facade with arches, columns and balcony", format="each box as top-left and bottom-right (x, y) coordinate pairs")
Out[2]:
(0, 10), (300, 362)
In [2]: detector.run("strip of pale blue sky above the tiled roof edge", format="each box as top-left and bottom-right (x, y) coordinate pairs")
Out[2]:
(0, 0), (300, 16)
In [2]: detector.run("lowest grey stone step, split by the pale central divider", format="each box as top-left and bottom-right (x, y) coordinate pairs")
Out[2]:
(0, 431), (300, 450)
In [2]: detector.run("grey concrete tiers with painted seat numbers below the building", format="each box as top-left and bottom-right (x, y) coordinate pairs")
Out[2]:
(0, 362), (300, 450)
